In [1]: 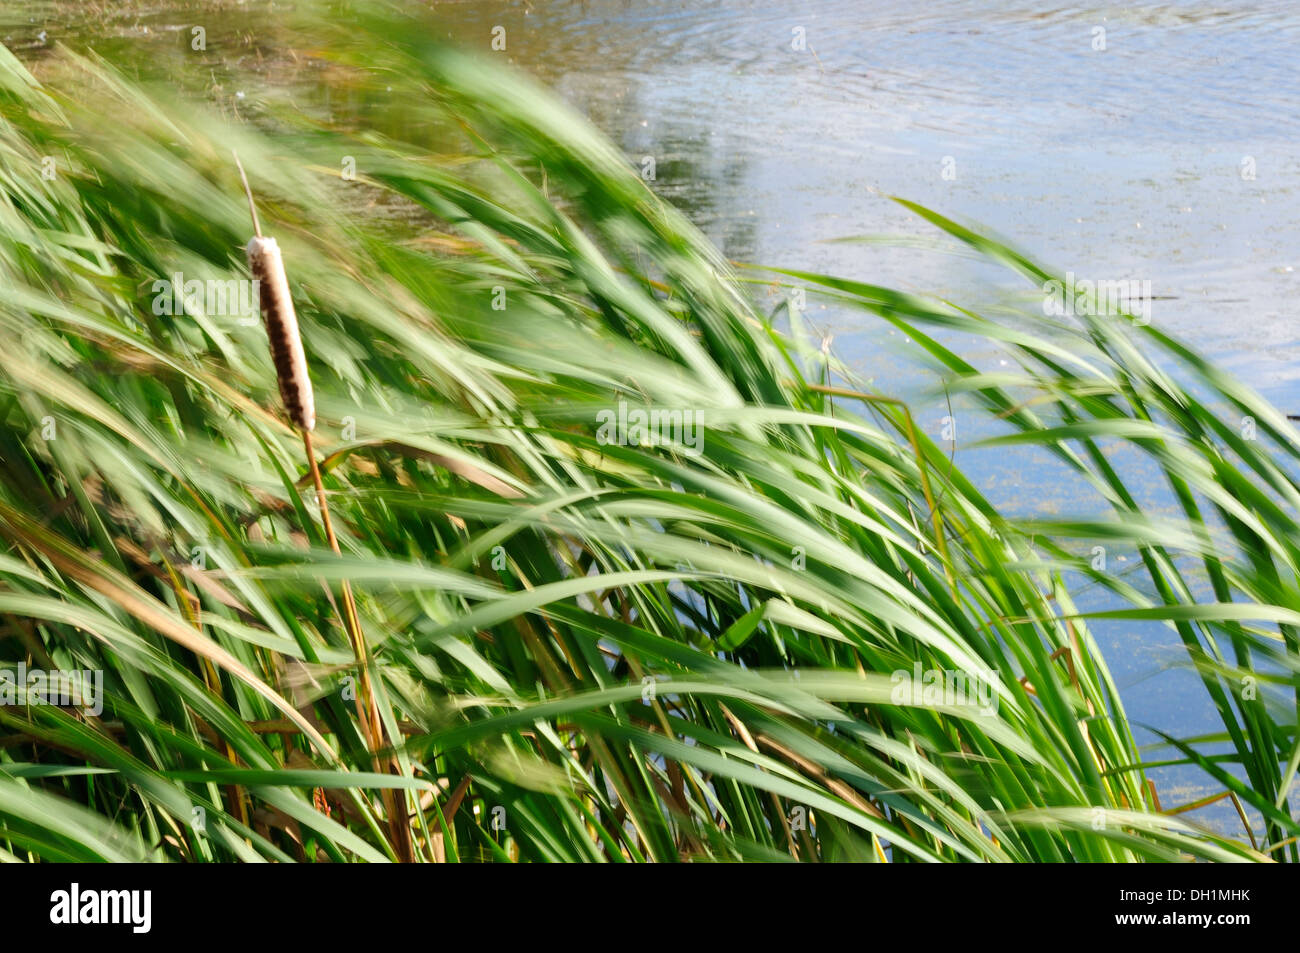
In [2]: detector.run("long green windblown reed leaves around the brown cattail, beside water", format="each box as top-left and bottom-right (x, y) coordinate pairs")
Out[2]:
(0, 7), (1300, 862)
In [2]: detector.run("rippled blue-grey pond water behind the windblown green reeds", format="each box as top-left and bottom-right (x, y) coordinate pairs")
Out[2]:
(10, 0), (1300, 831)
